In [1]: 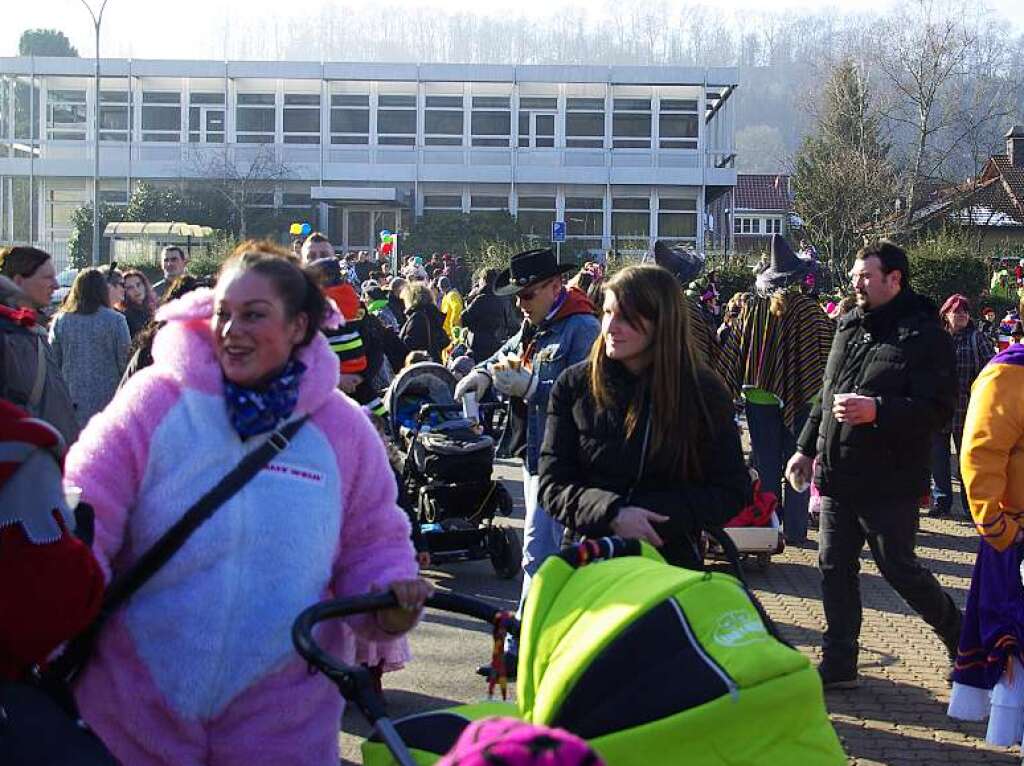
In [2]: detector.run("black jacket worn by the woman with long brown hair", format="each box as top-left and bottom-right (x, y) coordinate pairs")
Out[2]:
(540, 361), (751, 566)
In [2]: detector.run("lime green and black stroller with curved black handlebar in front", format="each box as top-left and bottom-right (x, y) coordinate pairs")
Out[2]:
(292, 535), (846, 766)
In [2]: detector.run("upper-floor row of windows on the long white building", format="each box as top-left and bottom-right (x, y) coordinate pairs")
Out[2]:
(37, 90), (699, 148)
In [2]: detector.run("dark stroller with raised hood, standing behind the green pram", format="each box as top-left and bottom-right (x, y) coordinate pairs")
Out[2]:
(387, 363), (522, 579)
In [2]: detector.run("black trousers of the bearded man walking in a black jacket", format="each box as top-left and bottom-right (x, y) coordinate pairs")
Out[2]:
(818, 497), (961, 669)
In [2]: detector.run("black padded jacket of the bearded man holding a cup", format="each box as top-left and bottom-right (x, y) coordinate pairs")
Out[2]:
(798, 290), (956, 503)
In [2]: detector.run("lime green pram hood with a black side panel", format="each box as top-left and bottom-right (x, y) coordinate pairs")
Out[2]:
(518, 545), (846, 766)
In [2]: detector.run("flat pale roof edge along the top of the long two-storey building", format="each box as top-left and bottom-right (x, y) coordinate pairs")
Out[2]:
(0, 56), (739, 87)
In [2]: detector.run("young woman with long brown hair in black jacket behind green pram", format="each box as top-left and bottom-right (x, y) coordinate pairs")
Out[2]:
(540, 266), (751, 567)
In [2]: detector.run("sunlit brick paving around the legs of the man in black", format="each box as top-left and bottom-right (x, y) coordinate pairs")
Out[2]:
(750, 516), (1021, 766)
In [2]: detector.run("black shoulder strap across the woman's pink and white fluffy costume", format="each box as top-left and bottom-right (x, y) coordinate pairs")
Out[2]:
(49, 415), (309, 681)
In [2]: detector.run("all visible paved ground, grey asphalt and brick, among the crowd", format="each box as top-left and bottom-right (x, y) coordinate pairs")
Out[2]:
(341, 458), (1020, 766)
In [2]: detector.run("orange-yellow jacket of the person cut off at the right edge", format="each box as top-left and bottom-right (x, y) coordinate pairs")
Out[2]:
(961, 346), (1024, 551)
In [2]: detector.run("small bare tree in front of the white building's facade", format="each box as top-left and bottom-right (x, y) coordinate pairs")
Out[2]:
(185, 144), (291, 239)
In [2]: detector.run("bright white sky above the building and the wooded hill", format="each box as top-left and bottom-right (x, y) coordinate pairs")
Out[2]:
(8, 0), (1024, 58)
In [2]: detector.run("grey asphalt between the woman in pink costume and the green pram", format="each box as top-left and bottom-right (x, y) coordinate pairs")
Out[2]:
(341, 461), (524, 764)
